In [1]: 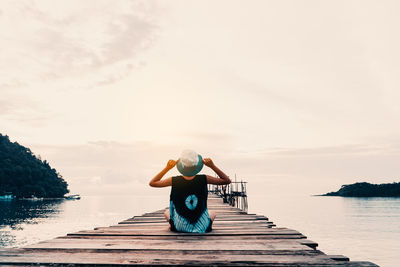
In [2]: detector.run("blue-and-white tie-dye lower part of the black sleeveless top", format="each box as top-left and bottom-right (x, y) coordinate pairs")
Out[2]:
(169, 201), (211, 233)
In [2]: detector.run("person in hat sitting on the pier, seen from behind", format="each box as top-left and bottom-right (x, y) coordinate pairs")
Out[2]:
(149, 150), (231, 233)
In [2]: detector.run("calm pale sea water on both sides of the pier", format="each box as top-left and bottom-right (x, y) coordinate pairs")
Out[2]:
(0, 194), (400, 267)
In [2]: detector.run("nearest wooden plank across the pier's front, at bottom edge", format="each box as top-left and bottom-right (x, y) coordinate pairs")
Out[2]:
(0, 249), (377, 267)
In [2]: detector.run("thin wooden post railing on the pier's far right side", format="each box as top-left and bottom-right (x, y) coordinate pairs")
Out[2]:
(208, 181), (248, 212)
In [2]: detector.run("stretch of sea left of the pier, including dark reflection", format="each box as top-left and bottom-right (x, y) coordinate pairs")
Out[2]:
(0, 195), (169, 248)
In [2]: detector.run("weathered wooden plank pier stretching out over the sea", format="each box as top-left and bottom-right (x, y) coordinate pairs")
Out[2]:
(0, 194), (377, 266)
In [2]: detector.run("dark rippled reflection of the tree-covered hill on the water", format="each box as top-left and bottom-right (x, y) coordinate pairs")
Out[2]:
(0, 199), (65, 247)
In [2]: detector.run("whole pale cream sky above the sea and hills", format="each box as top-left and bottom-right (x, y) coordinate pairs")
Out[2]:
(0, 0), (400, 197)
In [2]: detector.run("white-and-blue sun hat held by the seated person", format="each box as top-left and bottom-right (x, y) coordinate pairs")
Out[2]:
(176, 149), (203, 176)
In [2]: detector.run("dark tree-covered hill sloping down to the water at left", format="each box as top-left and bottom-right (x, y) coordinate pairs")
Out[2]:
(0, 134), (69, 198)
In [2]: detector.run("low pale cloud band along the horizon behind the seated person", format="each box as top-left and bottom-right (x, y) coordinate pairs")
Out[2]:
(25, 140), (400, 197)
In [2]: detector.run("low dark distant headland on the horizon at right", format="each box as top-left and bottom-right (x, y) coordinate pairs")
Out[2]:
(320, 182), (400, 197)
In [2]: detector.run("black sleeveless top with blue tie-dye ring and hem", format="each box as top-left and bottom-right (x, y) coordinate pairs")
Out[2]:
(170, 174), (211, 233)
